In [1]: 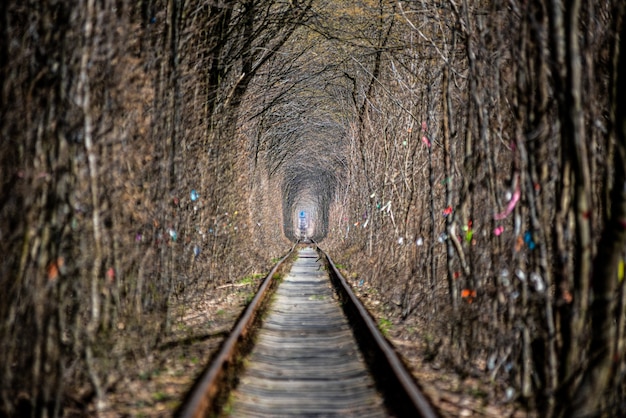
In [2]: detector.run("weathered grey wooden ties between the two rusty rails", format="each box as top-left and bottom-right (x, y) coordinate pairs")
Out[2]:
(229, 248), (388, 417)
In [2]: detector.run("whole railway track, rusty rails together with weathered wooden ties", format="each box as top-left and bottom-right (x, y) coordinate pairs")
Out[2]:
(177, 246), (437, 418)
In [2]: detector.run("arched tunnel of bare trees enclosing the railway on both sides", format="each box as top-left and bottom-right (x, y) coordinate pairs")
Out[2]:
(0, 0), (626, 417)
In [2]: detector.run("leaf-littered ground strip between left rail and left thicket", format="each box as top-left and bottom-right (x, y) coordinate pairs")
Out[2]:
(90, 277), (262, 418)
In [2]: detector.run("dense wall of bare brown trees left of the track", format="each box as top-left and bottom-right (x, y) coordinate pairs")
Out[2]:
(0, 0), (309, 416)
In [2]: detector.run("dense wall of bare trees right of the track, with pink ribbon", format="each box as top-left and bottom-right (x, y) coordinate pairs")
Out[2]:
(312, 0), (626, 416)
